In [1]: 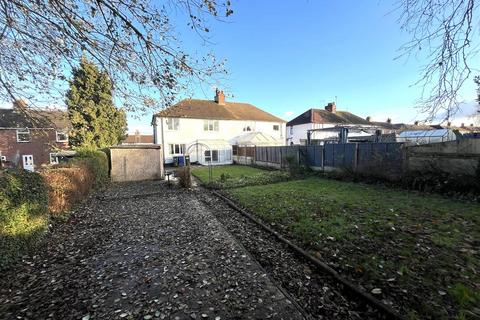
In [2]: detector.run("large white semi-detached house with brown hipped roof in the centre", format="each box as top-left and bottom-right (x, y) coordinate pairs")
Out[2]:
(152, 90), (285, 164)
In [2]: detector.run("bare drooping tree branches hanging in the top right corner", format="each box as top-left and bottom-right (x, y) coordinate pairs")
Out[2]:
(397, 0), (479, 121)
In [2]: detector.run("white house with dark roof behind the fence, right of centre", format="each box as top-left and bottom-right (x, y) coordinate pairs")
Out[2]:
(287, 102), (376, 145)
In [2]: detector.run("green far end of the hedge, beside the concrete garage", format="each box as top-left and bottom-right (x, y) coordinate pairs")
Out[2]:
(71, 148), (110, 190)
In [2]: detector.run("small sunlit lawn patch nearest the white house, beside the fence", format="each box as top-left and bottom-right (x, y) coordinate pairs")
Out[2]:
(192, 165), (290, 189)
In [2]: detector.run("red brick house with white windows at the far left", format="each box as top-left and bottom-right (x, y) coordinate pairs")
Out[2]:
(0, 101), (72, 171)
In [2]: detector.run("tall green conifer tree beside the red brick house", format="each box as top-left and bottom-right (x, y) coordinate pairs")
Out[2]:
(66, 57), (127, 148)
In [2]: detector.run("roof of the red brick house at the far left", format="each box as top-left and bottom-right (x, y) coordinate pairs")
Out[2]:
(0, 108), (71, 129)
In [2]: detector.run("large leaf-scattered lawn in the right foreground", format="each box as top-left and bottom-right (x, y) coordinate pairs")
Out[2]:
(228, 177), (480, 319)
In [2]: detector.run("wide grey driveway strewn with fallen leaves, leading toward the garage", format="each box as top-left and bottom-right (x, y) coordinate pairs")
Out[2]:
(0, 182), (303, 320)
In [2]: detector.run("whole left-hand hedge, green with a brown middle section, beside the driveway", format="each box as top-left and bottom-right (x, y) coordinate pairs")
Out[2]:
(0, 150), (109, 269)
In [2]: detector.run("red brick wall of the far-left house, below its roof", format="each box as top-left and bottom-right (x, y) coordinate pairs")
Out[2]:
(0, 129), (68, 168)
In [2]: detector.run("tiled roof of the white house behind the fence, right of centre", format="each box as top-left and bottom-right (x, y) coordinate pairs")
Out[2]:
(287, 109), (371, 127)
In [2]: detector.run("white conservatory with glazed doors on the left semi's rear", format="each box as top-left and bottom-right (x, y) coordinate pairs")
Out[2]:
(186, 139), (233, 165)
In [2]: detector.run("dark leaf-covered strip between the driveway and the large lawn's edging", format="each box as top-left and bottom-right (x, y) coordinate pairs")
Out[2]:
(197, 191), (386, 319)
